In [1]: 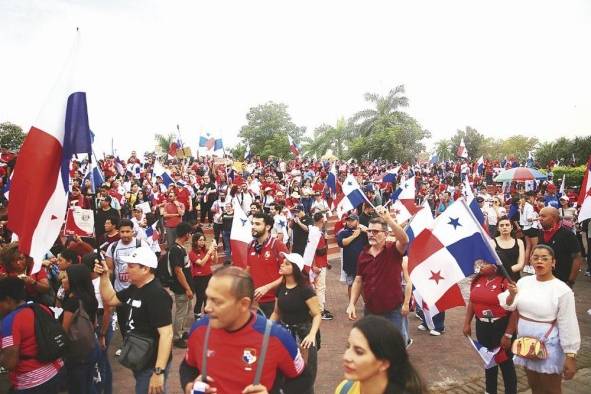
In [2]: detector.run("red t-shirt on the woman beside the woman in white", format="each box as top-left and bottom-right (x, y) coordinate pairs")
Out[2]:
(470, 275), (509, 317)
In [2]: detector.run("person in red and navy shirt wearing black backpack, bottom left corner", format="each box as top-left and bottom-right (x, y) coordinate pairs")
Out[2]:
(0, 277), (64, 394)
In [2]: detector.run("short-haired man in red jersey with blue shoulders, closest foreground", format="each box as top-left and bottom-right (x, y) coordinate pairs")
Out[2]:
(179, 266), (304, 394)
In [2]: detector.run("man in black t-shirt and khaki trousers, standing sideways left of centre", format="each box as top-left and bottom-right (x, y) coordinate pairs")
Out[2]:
(168, 222), (193, 349)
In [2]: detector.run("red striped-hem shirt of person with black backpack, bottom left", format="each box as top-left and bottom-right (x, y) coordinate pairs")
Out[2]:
(0, 305), (64, 390)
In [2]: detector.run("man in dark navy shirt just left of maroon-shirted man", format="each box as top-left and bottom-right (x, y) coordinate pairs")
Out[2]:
(336, 213), (367, 298)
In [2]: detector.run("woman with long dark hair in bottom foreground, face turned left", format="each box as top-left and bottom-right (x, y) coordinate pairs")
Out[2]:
(335, 315), (426, 394)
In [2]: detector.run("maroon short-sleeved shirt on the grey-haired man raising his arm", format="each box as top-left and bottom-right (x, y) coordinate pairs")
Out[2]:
(357, 242), (404, 314)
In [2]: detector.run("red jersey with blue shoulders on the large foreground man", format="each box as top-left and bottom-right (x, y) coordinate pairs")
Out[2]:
(185, 314), (304, 394)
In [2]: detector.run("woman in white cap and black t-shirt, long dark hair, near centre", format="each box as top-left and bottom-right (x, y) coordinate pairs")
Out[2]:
(271, 253), (322, 393)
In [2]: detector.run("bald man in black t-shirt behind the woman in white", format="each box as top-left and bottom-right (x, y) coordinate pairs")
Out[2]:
(538, 207), (582, 287)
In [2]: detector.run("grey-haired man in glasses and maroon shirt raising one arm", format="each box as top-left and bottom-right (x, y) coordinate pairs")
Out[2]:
(347, 207), (408, 340)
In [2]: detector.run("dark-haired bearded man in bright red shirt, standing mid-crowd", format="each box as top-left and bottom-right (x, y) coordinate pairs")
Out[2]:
(246, 212), (289, 317)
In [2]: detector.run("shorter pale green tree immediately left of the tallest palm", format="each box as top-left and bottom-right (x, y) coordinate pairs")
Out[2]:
(303, 117), (353, 159)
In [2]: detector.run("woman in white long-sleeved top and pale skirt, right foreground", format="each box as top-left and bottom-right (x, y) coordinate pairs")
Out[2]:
(499, 245), (581, 394)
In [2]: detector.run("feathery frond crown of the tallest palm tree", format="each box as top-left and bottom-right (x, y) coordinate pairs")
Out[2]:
(351, 85), (408, 136)
